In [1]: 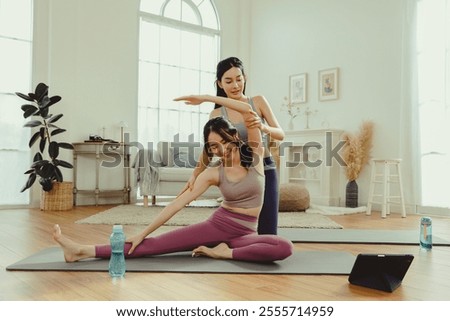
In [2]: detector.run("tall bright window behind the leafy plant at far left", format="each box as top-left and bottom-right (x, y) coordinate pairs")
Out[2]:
(0, 0), (33, 206)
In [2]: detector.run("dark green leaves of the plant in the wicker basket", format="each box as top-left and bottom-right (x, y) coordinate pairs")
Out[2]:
(16, 83), (73, 192)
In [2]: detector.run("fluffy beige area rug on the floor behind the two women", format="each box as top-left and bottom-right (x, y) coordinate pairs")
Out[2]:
(76, 205), (342, 229)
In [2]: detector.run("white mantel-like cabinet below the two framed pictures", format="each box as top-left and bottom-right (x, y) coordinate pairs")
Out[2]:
(280, 129), (344, 206)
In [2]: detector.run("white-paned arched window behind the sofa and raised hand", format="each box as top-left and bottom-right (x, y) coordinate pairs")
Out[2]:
(138, 0), (220, 147)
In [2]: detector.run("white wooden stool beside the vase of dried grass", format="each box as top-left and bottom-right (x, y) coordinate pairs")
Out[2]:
(366, 159), (406, 218)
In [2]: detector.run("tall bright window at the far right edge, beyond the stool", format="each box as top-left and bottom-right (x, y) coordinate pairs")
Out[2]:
(412, 0), (450, 213)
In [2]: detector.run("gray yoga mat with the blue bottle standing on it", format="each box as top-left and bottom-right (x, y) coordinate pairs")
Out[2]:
(278, 228), (450, 246)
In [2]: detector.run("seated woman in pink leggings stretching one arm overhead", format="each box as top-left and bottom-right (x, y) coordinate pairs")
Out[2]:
(53, 95), (293, 262)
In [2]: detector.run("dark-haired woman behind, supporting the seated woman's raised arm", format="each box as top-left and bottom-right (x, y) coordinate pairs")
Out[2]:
(185, 57), (284, 234)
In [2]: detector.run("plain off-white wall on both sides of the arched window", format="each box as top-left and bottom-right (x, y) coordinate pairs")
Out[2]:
(32, 0), (413, 209)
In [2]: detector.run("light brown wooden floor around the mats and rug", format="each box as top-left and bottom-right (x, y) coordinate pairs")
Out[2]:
(0, 206), (450, 301)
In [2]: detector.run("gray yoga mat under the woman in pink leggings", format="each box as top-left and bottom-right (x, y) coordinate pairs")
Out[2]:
(6, 247), (355, 275)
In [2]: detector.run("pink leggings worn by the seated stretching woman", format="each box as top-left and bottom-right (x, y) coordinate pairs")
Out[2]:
(95, 207), (293, 262)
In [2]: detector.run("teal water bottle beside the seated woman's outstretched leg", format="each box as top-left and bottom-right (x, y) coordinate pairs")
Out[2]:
(109, 225), (126, 277)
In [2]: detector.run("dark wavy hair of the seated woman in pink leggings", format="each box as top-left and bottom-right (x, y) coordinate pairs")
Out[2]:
(203, 116), (253, 168)
